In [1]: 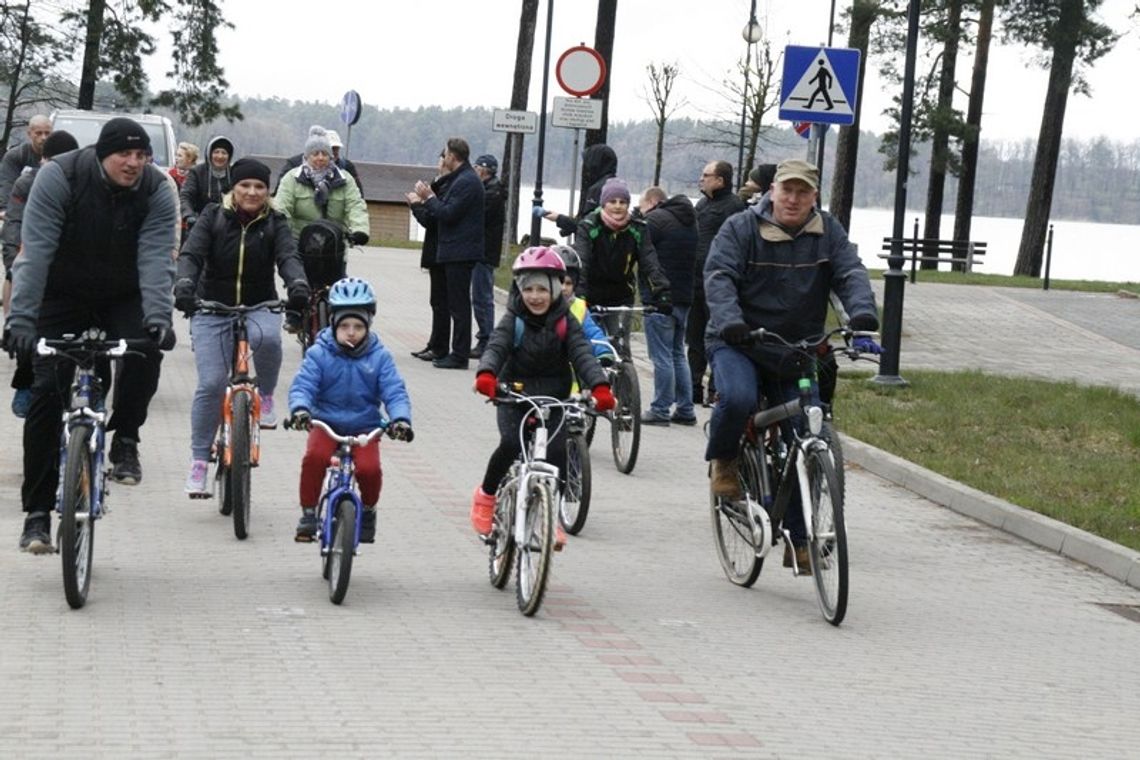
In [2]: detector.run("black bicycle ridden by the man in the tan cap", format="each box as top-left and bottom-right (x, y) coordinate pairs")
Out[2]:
(710, 327), (868, 626)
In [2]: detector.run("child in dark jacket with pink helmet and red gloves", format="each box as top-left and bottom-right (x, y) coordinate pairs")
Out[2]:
(471, 247), (613, 549)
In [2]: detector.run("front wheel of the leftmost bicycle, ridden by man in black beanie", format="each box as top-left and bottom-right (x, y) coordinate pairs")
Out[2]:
(58, 426), (95, 610)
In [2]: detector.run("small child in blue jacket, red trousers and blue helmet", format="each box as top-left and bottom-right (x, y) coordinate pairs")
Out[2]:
(288, 277), (412, 544)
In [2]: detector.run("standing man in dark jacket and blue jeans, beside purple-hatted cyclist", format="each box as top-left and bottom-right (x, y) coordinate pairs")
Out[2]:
(640, 187), (697, 425)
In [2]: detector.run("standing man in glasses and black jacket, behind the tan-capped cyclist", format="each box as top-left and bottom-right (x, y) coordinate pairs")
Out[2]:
(685, 161), (748, 406)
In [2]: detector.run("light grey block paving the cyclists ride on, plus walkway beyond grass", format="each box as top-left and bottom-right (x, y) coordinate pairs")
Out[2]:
(0, 248), (1140, 758)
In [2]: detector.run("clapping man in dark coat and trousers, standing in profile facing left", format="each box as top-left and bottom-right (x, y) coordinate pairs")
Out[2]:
(407, 137), (483, 369)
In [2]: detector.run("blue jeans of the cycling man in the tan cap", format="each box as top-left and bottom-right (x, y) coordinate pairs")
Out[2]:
(705, 345), (820, 544)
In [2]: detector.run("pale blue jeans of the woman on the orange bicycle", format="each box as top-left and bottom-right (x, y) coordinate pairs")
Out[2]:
(190, 311), (284, 459)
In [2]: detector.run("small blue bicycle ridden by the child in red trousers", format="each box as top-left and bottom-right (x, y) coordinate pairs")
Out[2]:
(285, 419), (412, 604)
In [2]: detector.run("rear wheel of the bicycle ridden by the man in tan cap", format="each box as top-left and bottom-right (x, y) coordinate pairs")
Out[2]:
(709, 443), (767, 588)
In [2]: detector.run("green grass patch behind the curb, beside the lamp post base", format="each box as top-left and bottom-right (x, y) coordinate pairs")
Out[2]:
(836, 370), (1140, 550)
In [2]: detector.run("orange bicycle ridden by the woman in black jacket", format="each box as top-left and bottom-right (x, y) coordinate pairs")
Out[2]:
(190, 300), (285, 541)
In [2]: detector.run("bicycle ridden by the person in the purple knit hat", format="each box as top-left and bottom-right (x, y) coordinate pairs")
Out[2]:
(587, 305), (656, 475)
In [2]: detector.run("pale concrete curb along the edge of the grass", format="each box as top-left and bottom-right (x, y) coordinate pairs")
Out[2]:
(842, 435), (1140, 589)
